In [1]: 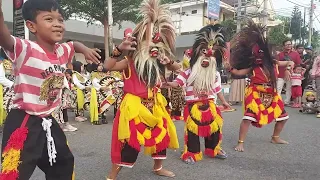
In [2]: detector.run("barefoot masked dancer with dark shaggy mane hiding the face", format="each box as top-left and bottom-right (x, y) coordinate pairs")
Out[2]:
(225, 20), (294, 152)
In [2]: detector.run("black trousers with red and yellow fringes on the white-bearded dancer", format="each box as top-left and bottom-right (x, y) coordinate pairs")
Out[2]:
(181, 100), (223, 162)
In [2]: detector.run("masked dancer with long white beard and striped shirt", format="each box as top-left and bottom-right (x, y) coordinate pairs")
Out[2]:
(168, 24), (228, 164)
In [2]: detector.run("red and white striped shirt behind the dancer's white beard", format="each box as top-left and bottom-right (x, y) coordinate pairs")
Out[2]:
(174, 69), (222, 102)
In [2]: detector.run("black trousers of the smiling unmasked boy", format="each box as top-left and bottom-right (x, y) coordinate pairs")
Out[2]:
(0, 109), (74, 180)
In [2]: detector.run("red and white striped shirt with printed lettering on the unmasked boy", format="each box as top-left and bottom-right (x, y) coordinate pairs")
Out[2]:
(6, 37), (74, 117)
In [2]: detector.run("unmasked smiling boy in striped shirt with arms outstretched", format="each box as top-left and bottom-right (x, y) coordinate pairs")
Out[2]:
(0, 0), (100, 180)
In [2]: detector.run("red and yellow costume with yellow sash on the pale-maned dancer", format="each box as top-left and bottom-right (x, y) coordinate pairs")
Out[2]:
(111, 59), (179, 167)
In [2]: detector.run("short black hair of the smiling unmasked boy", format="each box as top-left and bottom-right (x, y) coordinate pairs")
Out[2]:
(22, 0), (63, 22)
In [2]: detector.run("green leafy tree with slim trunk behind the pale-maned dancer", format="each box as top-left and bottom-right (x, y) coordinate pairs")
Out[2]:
(59, 0), (177, 56)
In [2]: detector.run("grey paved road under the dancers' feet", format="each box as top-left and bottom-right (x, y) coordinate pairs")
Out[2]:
(0, 106), (320, 180)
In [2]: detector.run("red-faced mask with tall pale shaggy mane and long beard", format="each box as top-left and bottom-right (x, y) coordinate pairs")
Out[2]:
(132, 0), (176, 87)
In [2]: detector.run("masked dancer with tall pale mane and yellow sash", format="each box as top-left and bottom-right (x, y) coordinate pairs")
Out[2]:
(105, 0), (180, 179)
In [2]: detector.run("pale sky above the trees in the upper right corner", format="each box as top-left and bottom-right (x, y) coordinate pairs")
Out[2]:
(271, 0), (320, 30)
